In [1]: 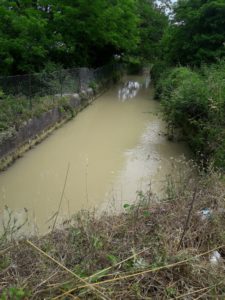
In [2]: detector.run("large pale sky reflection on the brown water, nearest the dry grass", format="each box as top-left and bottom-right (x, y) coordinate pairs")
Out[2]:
(102, 114), (189, 211)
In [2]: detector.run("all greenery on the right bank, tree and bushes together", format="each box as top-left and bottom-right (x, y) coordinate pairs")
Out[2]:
(153, 0), (225, 170)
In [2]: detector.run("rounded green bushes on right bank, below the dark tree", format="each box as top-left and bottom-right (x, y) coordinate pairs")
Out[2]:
(159, 61), (225, 170)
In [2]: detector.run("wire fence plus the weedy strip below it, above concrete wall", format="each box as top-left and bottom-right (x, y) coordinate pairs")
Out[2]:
(0, 64), (121, 133)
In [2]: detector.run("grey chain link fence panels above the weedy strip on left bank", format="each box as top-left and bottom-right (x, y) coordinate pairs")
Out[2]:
(0, 65), (115, 100)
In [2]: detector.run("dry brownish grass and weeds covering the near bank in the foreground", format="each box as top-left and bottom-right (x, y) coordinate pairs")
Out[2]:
(0, 162), (225, 300)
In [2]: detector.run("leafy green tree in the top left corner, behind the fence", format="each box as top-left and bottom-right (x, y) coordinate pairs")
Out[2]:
(0, 1), (48, 74)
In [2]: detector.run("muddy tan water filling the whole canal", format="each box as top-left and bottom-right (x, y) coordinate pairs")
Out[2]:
(0, 77), (188, 233)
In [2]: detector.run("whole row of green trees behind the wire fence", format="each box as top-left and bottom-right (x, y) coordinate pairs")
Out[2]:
(0, 0), (167, 75)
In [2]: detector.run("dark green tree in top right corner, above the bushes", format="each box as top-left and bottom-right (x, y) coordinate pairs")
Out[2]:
(162, 0), (225, 65)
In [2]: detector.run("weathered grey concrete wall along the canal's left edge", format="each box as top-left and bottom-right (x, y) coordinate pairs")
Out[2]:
(0, 88), (99, 171)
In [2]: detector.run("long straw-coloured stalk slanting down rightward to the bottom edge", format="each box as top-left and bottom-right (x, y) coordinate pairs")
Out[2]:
(27, 240), (110, 300)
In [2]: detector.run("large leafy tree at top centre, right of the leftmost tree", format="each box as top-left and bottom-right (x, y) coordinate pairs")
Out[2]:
(46, 0), (138, 66)
